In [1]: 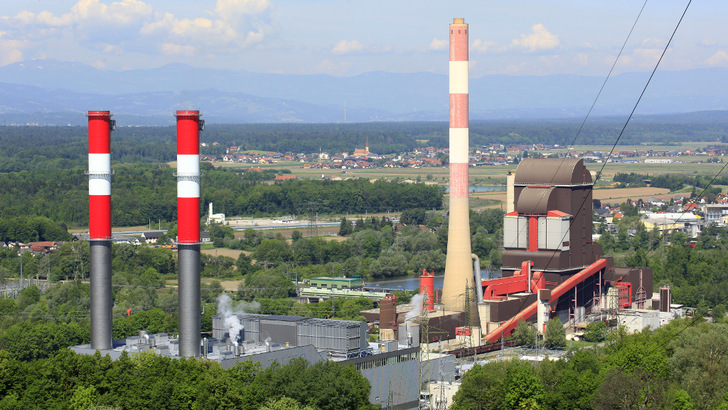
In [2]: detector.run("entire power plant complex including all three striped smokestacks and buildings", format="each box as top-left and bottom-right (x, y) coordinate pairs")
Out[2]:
(72, 18), (684, 409)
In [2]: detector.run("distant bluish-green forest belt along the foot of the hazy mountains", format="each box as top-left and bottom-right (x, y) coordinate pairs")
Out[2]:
(0, 113), (728, 172)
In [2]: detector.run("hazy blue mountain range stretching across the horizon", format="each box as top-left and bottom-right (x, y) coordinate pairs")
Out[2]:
(0, 60), (728, 126)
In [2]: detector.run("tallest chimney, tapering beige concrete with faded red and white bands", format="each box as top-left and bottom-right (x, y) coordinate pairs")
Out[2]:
(442, 18), (480, 326)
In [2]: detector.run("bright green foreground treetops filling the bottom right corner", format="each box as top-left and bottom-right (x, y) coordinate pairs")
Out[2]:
(452, 318), (728, 410)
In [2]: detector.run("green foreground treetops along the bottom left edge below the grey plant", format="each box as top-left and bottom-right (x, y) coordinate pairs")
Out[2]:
(0, 349), (378, 410)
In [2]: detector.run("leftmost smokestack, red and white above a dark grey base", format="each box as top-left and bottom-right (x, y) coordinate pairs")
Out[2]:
(87, 111), (114, 350)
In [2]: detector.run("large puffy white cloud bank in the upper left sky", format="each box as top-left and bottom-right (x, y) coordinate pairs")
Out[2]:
(0, 0), (272, 60)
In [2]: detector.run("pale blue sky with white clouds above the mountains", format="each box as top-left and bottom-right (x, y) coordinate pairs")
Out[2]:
(0, 0), (728, 77)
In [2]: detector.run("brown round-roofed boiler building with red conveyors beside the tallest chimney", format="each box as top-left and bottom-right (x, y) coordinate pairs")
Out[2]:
(370, 158), (653, 350)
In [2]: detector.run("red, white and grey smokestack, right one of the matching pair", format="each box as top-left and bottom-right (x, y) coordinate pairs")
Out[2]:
(176, 111), (204, 357)
